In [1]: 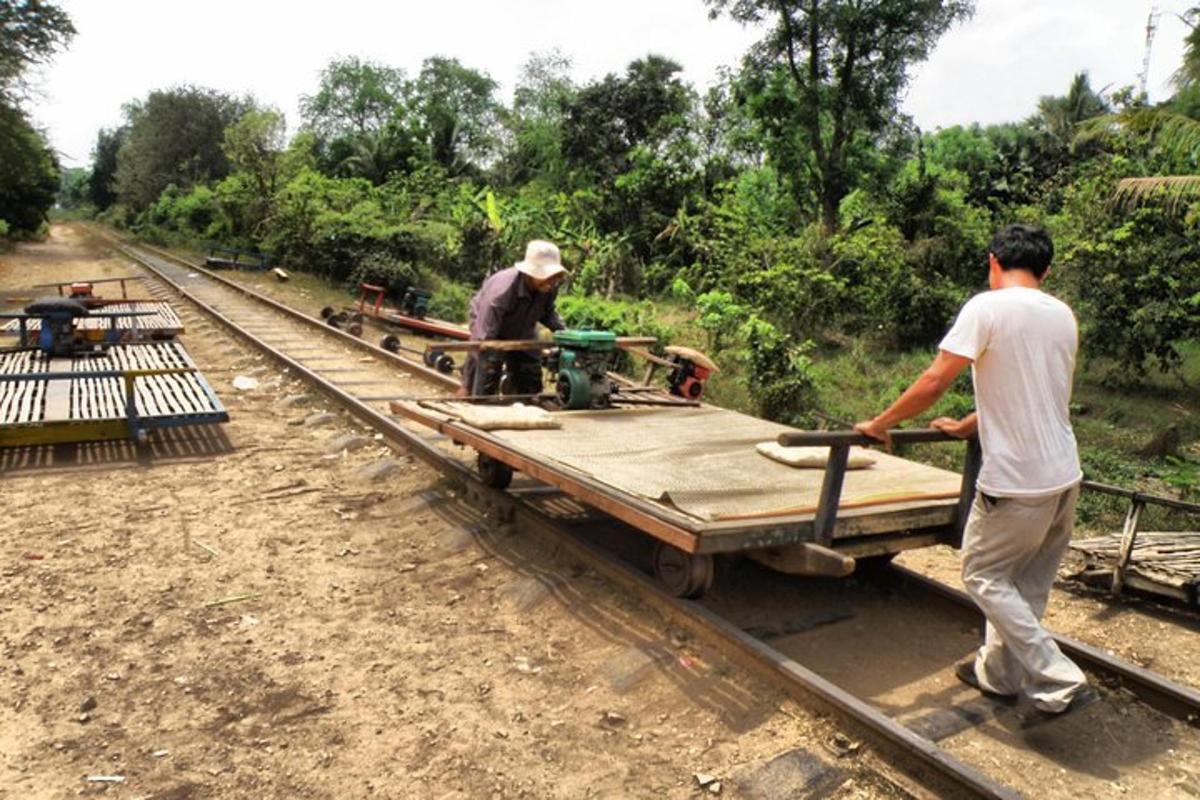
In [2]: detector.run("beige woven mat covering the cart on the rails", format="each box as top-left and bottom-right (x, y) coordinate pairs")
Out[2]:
(480, 407), (961, 521)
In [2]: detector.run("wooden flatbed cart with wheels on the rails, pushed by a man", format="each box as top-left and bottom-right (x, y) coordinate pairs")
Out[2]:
(391, 401), (979, 596)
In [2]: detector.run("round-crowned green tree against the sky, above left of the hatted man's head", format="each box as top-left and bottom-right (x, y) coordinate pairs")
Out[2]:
(412, 56), (500, 176)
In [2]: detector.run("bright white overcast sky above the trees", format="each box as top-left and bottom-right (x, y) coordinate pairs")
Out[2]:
(32, 0), (1193, 166)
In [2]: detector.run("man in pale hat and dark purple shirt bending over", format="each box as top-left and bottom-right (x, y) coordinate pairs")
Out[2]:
(458, 240), (566, 396)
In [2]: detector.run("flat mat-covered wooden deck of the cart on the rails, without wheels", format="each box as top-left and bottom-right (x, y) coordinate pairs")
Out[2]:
(392, 402), (962, 557)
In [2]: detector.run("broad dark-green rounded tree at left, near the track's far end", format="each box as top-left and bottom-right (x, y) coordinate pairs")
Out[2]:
(115, 86), (252, 211)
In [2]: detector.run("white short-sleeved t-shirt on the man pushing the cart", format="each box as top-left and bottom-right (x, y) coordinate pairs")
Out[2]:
(938, 287), (1084, 497)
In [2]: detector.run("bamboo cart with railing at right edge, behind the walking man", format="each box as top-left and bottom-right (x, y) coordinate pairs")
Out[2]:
(1070, 481), (1200, 606)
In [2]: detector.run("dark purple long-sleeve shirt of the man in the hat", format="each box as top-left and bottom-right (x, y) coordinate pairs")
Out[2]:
(470, 266), (566, 339)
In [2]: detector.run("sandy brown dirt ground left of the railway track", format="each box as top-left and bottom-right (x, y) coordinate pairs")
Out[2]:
(0, 225), (902, 800)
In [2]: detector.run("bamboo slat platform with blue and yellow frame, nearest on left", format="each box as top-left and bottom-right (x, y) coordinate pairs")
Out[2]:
(0, 342), (229, 446)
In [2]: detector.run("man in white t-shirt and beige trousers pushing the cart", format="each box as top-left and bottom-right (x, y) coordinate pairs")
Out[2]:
(854, 225), (1098, 727)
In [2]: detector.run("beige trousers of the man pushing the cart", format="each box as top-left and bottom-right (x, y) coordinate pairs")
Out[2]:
(962, 486), (1087, 711)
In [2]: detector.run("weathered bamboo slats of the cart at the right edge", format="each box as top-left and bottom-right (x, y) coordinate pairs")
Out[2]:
(1070, 531), (1200, 603)
